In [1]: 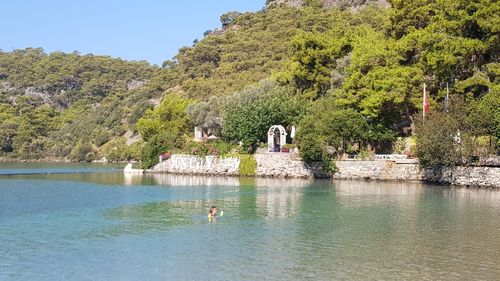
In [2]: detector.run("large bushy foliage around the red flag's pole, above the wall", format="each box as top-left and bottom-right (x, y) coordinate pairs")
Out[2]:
(417, 92), (500, 166)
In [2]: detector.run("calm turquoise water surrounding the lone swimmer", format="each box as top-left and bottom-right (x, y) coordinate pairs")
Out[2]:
(0, 164), (500, 280)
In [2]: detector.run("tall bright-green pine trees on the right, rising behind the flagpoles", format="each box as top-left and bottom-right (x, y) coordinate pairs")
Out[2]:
(284, 0), (500, 162)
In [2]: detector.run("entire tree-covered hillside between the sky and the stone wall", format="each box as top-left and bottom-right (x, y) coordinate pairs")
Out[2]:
(0, 0), (500, 166)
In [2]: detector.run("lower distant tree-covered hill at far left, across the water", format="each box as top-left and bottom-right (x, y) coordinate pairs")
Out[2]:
(0, 49), (159, 160)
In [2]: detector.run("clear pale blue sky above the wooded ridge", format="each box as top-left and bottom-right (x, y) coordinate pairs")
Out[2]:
(0, 0), (265, 65)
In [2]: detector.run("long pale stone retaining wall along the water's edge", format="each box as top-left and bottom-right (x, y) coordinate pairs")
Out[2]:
(148, 153), (500, 188)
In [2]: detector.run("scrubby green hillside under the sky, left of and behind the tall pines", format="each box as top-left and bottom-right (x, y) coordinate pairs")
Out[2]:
(0, 5), (390, 160)
